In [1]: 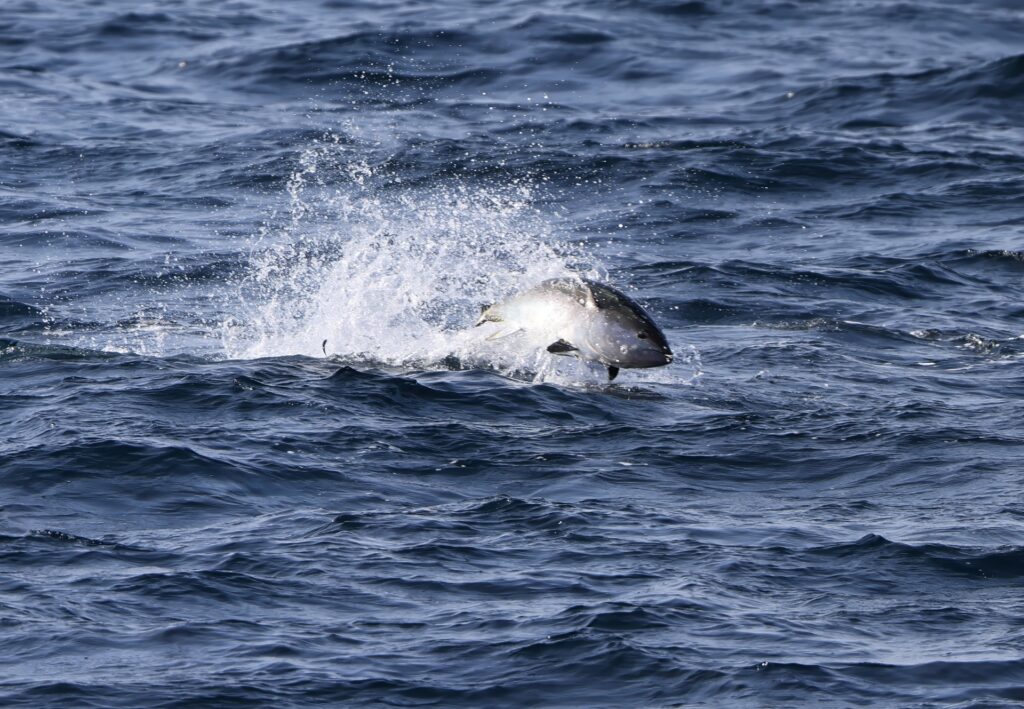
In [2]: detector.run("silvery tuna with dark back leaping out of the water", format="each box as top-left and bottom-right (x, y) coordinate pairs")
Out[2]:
(476, 278), (672, 381)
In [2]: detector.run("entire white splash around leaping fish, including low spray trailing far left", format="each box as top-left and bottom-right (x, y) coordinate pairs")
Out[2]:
(32, 135), (701, 387)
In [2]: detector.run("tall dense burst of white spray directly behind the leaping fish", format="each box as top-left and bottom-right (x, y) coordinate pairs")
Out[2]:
(223, 137), (601, 373)
